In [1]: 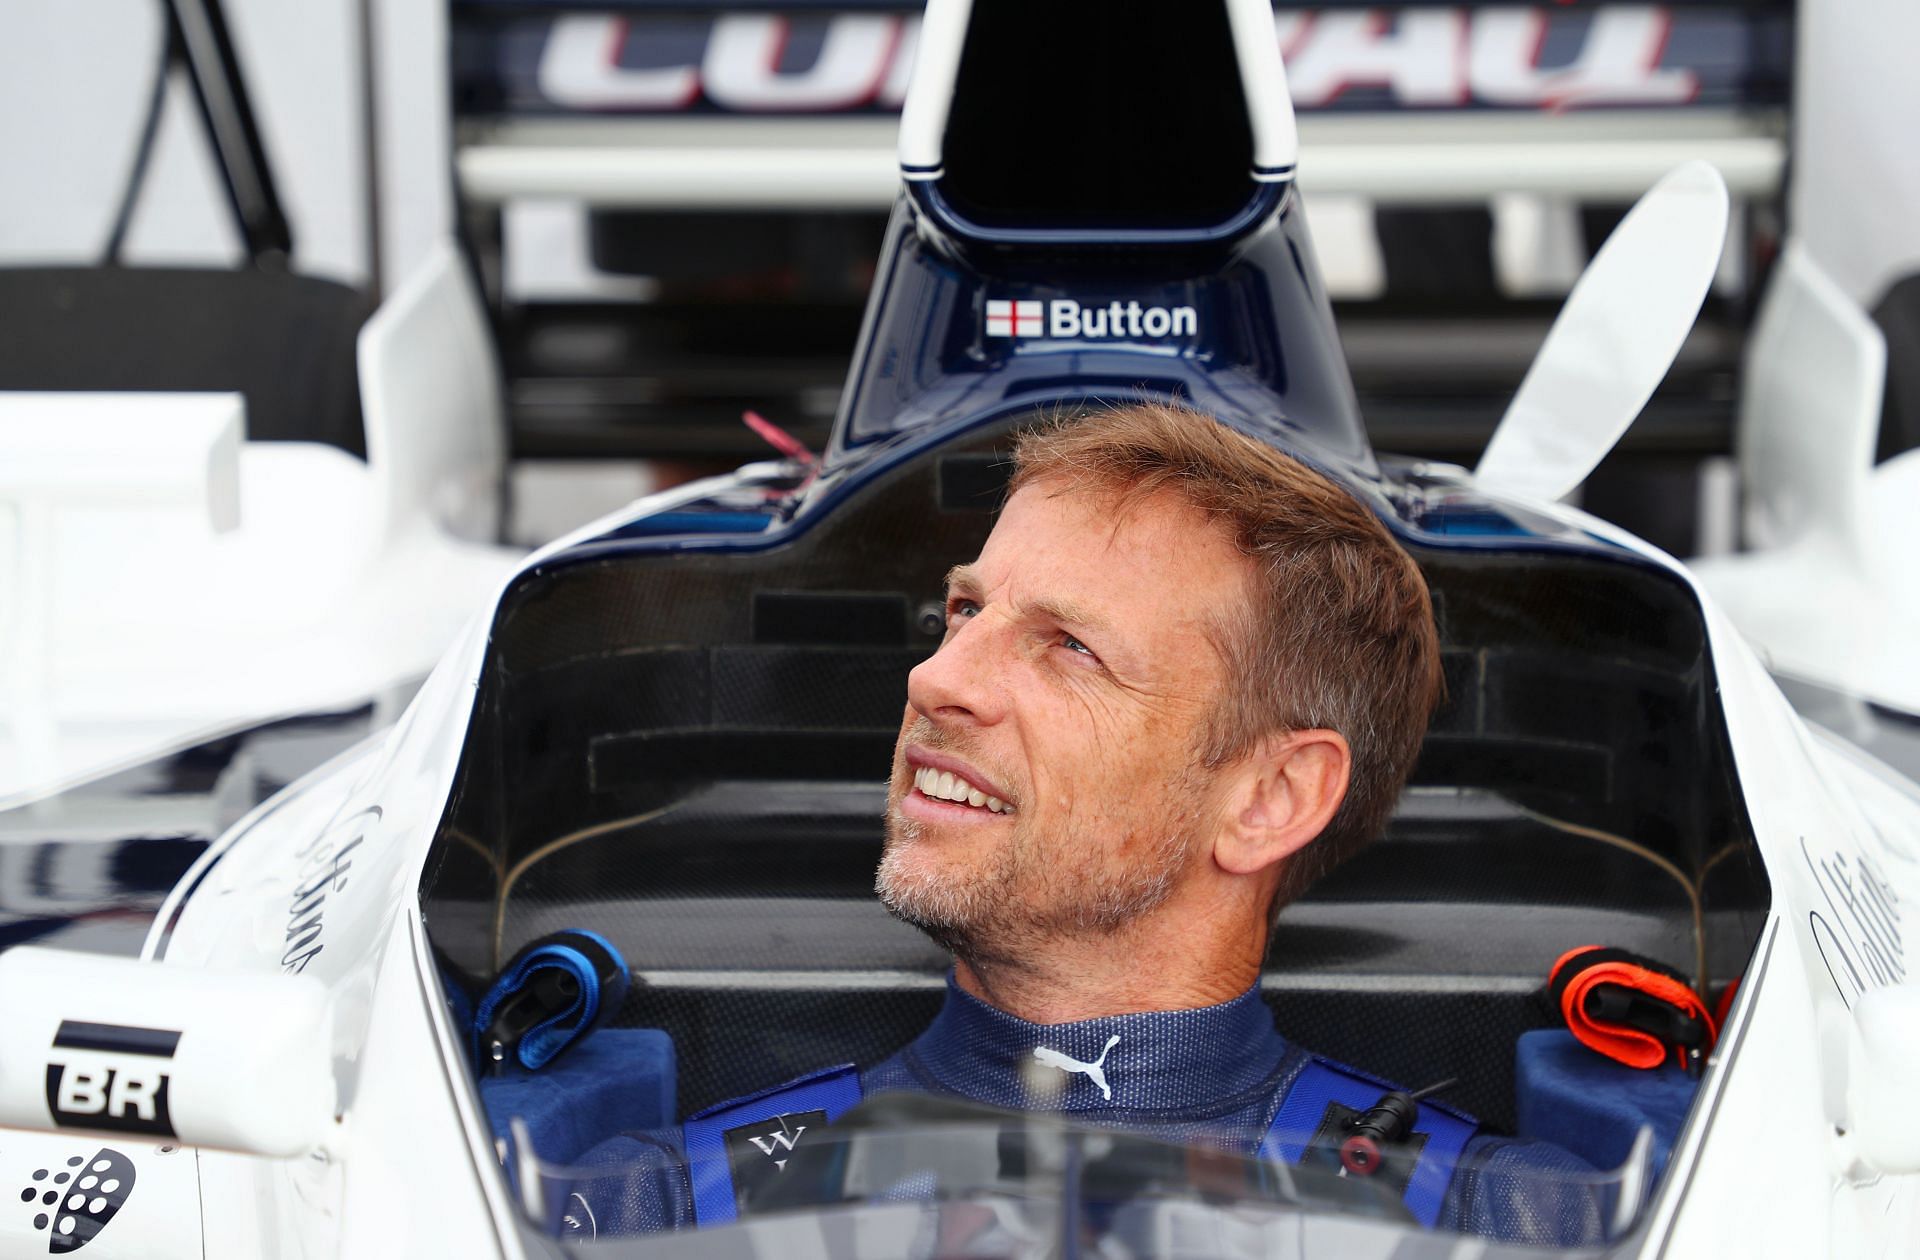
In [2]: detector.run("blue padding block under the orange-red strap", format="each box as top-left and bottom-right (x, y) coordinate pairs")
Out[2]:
(1513, 1028), (1699, 1175)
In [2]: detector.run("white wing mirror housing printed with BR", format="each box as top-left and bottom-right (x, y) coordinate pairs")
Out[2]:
(0, 947), (338, 1156)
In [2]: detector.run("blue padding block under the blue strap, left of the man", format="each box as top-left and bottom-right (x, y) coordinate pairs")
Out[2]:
(480, 1028), (676, 1164)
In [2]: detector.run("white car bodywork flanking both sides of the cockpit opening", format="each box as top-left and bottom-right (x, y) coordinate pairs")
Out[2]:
(0, 457), (1920, 1258)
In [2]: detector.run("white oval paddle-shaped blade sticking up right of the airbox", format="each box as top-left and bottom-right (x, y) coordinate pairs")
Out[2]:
(1475, 161), (1726, 499)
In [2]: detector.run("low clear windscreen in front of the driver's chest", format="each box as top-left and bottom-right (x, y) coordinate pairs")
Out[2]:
(509, 1095), (1647, 1260)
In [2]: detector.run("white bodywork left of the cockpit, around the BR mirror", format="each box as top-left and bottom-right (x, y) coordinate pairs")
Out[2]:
(0, 471), (745, 1260)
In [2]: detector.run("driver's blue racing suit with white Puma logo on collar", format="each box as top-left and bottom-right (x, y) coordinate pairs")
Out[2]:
(561, 978), (1603, 1245)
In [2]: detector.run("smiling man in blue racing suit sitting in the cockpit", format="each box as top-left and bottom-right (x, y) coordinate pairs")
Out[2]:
(568, 405), (1599, 1243)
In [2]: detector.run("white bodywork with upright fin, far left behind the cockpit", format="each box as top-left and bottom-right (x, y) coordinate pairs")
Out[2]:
(0, 244), (520, 807)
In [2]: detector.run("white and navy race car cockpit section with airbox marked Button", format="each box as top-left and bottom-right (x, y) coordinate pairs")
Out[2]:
(0, 0), (1920, 1256)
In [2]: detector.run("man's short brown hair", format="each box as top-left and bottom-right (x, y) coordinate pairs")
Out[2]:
(1010, 403), (1440, 909)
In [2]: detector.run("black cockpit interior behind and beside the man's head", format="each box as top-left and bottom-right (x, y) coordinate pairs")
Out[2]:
(420, 411), (1768, 1236)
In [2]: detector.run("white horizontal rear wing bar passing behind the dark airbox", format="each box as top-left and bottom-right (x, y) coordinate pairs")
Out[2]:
(457, 109), (1786, 209)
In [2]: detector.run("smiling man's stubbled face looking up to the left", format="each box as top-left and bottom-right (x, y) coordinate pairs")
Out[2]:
(877, 482), (1248, 960)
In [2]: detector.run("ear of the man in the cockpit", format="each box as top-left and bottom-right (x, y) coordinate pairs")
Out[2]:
(1213, 730), (1354, 876)
